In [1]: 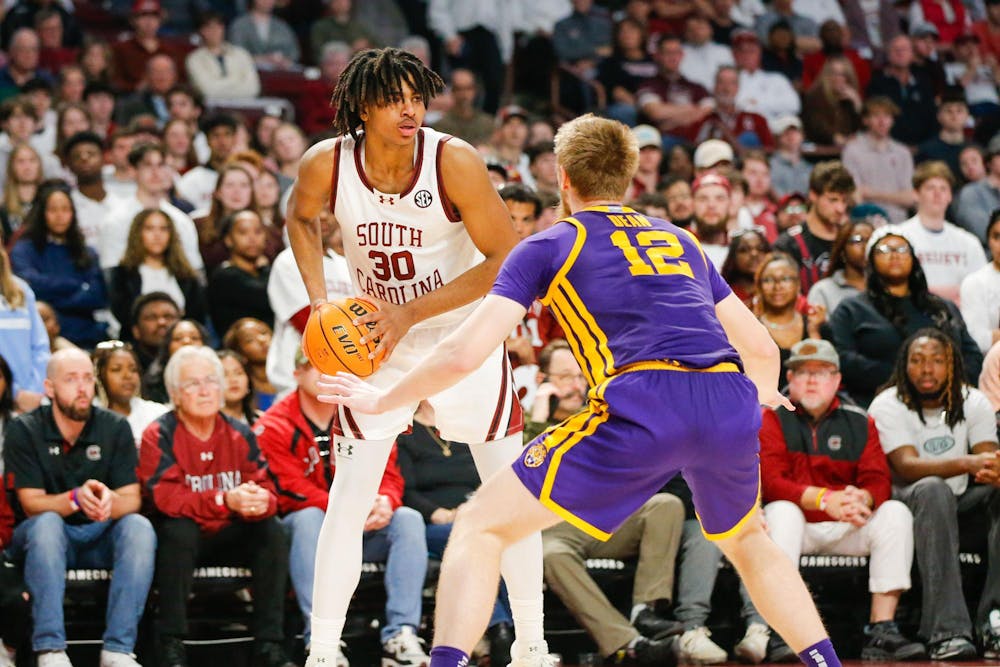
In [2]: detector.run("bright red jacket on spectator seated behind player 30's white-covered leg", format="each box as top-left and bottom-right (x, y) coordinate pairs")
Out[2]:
(253, 391), (403, 514)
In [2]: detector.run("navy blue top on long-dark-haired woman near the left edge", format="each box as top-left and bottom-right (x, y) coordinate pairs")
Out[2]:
(10, 238), (108, 349)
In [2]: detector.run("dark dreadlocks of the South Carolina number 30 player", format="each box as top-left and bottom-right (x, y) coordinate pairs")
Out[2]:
(330, 48), (444, 139)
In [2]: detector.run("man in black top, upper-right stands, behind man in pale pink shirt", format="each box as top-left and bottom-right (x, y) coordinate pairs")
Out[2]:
(865, 35), (937, 146)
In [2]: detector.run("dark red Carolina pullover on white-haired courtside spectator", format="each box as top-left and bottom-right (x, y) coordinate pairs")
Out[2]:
(139, 411), (278, 533)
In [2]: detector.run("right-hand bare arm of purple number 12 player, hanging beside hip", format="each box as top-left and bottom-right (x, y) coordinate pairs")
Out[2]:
(715, 294), (795, 410)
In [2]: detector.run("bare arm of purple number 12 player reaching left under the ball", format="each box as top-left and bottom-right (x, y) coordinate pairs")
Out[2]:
(317, 294), (526, 414)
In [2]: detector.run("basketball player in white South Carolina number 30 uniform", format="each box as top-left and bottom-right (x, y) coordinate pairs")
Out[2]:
(287, 48), (551, 667)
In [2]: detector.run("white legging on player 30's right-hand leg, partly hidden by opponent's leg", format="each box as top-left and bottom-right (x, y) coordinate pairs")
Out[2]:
(469, 433), (545, 646)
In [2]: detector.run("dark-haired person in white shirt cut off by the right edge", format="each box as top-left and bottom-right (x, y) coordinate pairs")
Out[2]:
(959, 210), (1000, 354)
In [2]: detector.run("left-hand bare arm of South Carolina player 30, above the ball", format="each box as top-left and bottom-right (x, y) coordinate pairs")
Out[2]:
(285, 139), (336, 306)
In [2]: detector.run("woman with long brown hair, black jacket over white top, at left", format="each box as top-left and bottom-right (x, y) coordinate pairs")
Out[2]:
(108, 209), (208, 341)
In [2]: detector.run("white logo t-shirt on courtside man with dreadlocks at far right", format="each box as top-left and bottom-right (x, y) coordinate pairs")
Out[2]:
(868, 387), (997, 496)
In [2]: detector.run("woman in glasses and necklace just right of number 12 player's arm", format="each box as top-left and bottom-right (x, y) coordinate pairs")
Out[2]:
(754, 252), (827, 386)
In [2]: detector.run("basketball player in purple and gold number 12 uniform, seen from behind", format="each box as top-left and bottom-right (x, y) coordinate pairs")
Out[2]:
(320, 115), (840, 667)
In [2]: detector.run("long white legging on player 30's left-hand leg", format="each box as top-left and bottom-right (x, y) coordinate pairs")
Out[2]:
(311, 436), (394, 652)
